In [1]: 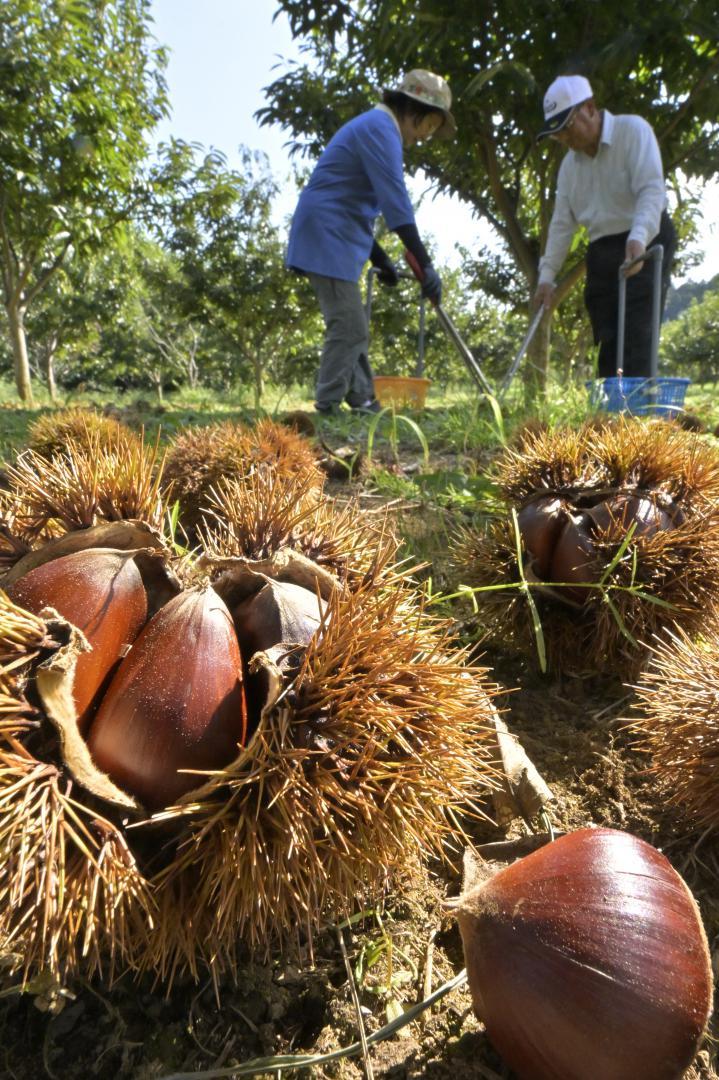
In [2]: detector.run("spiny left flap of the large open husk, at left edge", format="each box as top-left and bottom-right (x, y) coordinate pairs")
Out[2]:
(0, 591), (154, 985)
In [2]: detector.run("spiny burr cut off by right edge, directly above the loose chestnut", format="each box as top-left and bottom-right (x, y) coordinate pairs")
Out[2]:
(629, 622), (719, 832)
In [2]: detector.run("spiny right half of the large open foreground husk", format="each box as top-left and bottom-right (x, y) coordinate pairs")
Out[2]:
(142, 571), (496, 978)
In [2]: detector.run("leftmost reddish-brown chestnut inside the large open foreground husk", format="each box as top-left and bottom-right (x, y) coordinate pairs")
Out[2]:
(6, 548), (147, 734)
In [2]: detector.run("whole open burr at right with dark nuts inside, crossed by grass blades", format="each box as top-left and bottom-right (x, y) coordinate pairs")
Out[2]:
(456, 417), (719, 675)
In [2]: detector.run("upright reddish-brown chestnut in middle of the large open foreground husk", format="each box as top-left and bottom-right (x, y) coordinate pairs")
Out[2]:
(87, 588), (247, 810)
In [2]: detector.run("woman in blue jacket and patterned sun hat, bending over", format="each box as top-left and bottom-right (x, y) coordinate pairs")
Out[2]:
(287, 70), (457, 414)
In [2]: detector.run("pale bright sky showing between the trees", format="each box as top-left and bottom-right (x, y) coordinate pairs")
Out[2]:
(151, 0), (719, 280)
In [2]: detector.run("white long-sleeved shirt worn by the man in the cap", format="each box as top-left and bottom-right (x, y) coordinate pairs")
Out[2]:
(539, 109), (666, 284)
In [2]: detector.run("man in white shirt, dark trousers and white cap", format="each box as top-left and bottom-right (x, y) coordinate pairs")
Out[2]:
(534, 75), (676, 378)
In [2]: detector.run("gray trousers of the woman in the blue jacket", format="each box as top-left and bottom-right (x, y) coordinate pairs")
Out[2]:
(307, 273), (375, 408)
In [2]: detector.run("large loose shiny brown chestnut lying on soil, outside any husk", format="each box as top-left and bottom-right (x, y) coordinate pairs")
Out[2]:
(457, 828), (711, 1080)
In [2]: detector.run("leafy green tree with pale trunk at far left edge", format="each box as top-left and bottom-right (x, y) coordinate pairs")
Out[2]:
(0, 0), (166, 401)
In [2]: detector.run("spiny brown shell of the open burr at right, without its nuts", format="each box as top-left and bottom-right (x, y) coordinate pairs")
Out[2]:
(456, 417), (719, 675)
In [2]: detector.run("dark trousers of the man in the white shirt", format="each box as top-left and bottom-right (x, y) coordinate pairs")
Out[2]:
(584, 211), (677, 379)
